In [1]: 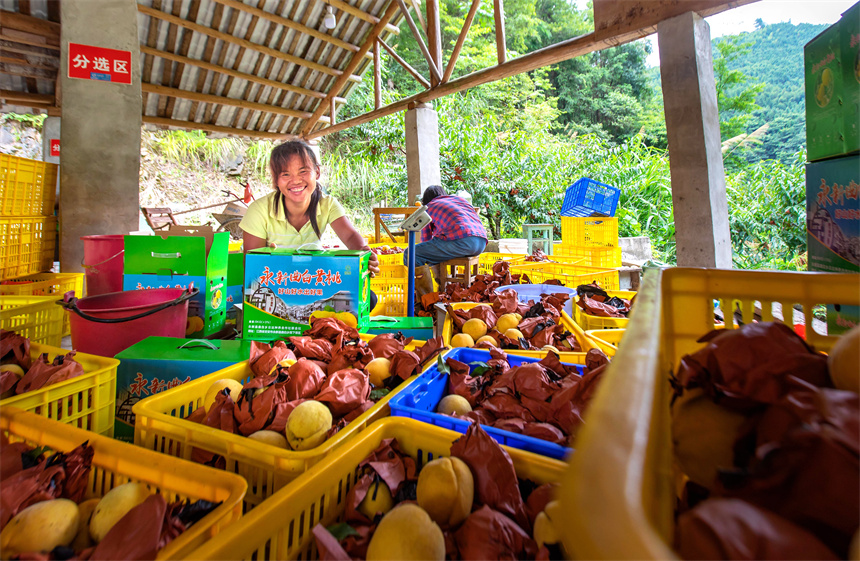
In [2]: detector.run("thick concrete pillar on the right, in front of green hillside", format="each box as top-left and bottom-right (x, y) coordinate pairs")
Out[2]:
(657, 12), (732, 269)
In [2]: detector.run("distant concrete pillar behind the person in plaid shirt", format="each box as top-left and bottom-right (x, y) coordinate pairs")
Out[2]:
(406, 103), (442, 206)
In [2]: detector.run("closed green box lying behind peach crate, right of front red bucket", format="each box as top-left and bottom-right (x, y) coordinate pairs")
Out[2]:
(114, 337), (251, 442)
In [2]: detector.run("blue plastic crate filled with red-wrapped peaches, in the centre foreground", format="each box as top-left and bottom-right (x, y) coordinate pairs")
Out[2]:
(388, 348), (583, 460)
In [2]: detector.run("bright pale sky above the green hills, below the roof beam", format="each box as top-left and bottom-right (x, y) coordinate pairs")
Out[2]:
(575, 0), (857, 66)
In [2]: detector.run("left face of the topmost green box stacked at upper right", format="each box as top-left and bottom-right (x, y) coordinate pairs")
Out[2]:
(803, 19), (845, 162)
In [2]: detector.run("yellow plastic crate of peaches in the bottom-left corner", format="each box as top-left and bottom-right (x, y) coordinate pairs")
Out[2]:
(0, 407), (247, 559)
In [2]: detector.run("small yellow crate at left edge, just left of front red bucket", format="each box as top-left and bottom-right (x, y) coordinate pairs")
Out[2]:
(0, 296), (66, 347)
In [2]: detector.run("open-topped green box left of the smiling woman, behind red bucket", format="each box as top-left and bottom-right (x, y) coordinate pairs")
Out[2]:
(123, 226), (230, 337)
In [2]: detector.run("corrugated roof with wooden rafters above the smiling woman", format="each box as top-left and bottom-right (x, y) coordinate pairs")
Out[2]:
(0, 0), (401, 136)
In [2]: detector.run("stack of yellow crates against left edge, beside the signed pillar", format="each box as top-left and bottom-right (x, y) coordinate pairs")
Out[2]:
(0, 154), (58, 280)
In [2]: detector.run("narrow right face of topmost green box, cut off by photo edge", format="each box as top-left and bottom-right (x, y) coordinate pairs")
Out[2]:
(839, 2), (860, 154)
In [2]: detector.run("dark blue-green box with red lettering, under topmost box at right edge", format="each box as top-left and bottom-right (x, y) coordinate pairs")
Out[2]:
(806, 155), (860, 335)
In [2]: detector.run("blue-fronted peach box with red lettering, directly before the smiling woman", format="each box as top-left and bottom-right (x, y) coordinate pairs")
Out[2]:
(242, 248), (370, 341)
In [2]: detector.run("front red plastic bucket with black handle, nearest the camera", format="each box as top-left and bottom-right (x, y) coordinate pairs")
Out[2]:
(58, 288), (198, 357)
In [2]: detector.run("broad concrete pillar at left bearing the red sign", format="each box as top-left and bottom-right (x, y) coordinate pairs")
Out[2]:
(60, 0), (141, 272)
